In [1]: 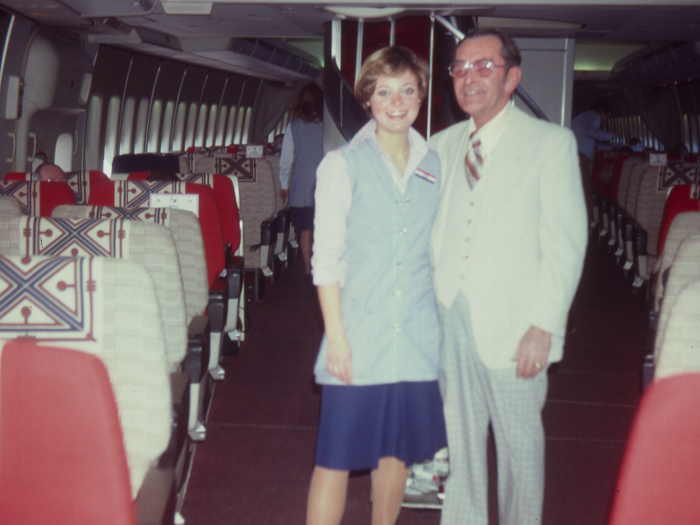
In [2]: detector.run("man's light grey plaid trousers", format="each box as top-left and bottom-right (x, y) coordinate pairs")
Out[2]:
(440, 293), (547, 525)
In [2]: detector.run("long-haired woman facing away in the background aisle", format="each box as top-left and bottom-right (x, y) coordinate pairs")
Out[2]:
(280, 83), (323, 279)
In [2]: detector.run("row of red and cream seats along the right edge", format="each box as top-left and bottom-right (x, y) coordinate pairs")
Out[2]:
(593, 152), (700, 525)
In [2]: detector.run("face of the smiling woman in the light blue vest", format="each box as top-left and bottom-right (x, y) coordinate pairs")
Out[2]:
(369, 69), (420, 133)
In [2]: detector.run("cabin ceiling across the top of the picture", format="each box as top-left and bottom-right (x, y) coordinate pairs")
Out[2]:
(0, 0), (700, 80)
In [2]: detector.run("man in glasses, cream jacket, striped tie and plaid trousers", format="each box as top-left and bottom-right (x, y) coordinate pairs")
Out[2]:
(431, 30), (587, 525)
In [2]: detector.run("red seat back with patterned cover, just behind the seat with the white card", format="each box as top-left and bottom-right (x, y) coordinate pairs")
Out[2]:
(88, 180), (225, 288)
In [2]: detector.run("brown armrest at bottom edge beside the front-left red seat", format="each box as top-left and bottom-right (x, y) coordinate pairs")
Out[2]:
(135, 467), (176, 525)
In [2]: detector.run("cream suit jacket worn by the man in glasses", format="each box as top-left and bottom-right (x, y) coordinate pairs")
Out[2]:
(430, 106), (588, 369)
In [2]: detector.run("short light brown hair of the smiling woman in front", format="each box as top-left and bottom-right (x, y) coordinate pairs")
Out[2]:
(355, 46), (430, 111)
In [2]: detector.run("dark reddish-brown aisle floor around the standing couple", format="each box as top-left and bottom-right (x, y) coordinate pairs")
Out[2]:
(182, 243), (644, 525)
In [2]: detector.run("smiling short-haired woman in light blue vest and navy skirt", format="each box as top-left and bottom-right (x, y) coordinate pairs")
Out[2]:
(307, 47), (447, 525)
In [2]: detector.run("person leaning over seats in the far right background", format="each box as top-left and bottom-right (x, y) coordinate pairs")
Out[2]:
(571, 99), (620, 215)
